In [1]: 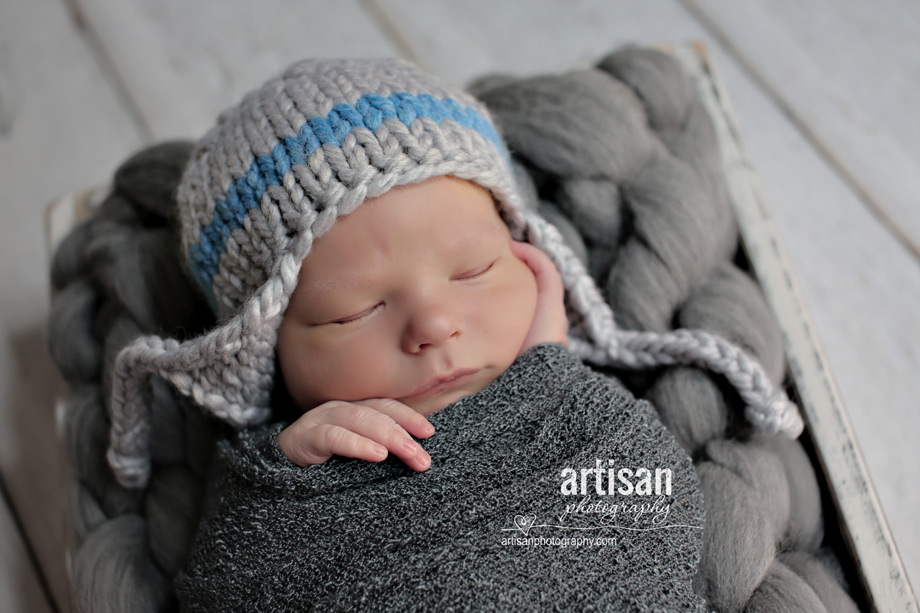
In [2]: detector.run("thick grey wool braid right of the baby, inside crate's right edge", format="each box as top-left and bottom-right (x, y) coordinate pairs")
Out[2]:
(474, 49), (855, 611)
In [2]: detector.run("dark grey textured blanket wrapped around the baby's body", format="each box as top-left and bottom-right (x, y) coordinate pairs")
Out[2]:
(176, 344), (704, 611)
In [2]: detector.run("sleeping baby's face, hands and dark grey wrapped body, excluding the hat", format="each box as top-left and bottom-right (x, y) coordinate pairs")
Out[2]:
(177, 176), (703, 611)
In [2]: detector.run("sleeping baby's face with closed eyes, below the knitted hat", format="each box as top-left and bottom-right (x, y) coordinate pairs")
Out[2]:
(278, 177), (537, 416)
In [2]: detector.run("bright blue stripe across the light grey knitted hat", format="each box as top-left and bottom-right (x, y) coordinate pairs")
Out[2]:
(189, 92), (508, 306)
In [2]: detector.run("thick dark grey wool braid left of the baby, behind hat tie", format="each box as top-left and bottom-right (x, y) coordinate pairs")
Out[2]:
(49, 143), (216, 613)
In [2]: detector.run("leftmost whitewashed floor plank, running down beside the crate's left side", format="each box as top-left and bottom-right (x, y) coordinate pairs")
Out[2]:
(0, 0), (142, 611)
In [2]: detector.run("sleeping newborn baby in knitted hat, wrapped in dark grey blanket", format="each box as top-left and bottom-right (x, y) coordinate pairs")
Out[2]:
(108, 55), (794, 611)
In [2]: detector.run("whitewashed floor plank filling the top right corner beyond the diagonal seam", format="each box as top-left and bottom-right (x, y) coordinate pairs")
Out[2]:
(687, 0), (920, 260)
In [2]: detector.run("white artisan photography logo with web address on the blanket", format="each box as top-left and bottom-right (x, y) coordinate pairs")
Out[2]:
(502, 459), (702, 548)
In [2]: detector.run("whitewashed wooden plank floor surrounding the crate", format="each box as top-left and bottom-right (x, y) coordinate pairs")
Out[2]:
(0, 0), (920, 612)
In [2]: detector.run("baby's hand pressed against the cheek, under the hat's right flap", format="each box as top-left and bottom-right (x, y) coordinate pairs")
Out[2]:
(511, 241), (569, 355)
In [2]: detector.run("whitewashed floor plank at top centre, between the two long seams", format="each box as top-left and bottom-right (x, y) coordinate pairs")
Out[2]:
(368, 0), (720, 83)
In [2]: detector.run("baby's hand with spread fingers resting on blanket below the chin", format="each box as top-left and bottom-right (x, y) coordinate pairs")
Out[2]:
(278, 398), (434, 471)
